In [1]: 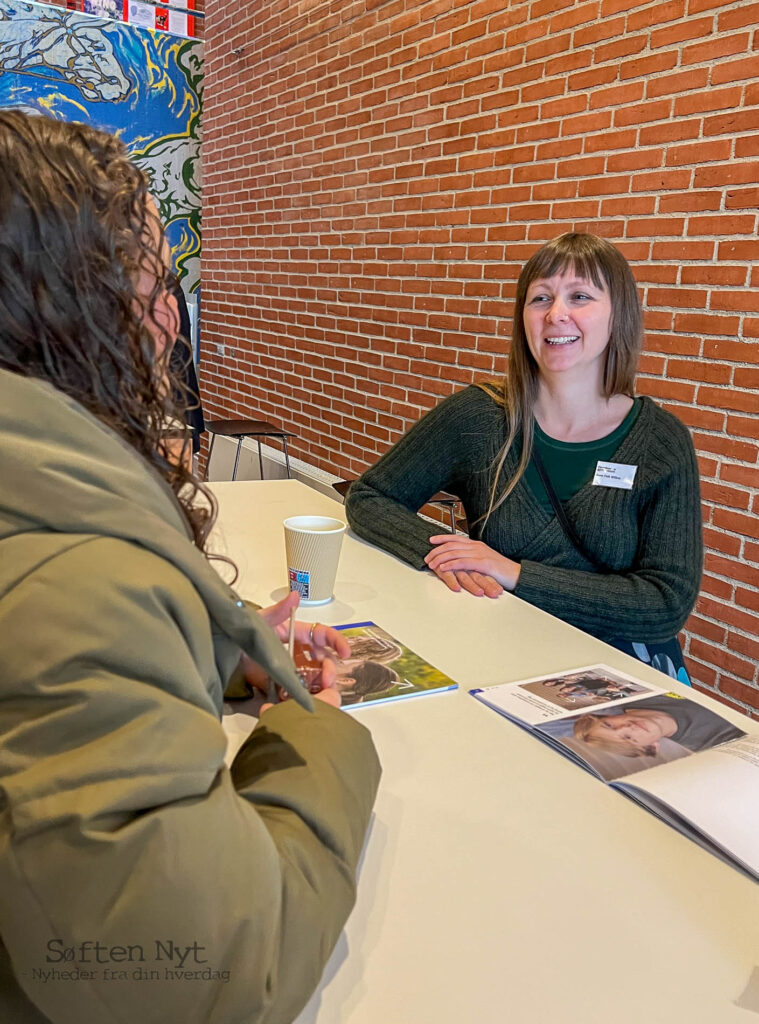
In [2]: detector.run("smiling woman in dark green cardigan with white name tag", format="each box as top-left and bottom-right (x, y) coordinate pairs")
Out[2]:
(346, 233), (702, 681)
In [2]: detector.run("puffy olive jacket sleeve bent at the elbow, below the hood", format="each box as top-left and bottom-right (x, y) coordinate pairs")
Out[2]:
(0, 539), (379, 1024)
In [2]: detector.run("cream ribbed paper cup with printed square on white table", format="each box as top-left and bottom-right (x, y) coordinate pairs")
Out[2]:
(284, 515), (345, 604)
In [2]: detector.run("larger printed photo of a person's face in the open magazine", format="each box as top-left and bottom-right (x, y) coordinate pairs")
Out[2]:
(536, 693), (746, 780)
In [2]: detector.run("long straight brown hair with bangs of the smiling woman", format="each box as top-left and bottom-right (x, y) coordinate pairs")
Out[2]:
(479, 231), (643, 521)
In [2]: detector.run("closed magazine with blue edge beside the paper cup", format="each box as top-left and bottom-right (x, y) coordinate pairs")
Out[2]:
(335, 623), (458, 708)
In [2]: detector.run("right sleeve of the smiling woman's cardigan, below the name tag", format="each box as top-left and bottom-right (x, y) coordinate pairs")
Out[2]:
(514, 417), (703, 643)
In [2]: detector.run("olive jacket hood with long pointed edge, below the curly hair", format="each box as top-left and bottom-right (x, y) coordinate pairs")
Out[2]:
(0, 370), (312, 710)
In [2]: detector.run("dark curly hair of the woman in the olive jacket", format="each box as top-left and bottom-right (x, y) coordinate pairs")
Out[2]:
(0, 110), (216, 551)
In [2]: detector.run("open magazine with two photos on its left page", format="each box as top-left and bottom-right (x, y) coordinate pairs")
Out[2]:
(470, 665), (759, 881)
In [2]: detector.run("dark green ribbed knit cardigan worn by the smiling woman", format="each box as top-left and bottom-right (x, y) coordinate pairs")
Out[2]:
(346, 387), (702, 643)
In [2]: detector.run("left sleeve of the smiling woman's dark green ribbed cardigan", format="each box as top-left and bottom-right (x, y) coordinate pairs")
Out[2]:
(345, 387), (496, 569)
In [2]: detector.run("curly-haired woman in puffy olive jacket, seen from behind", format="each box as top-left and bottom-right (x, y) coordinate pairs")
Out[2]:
(0, 111), (379, 1024)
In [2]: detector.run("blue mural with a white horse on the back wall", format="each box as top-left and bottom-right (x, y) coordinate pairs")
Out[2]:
(0, 0), (203, 292)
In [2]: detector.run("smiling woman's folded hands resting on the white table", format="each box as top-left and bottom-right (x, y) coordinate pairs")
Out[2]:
(424, 534), (520, 597)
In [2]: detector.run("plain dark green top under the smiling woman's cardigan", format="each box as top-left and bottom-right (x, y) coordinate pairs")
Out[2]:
(524, 398), (641, 515)
